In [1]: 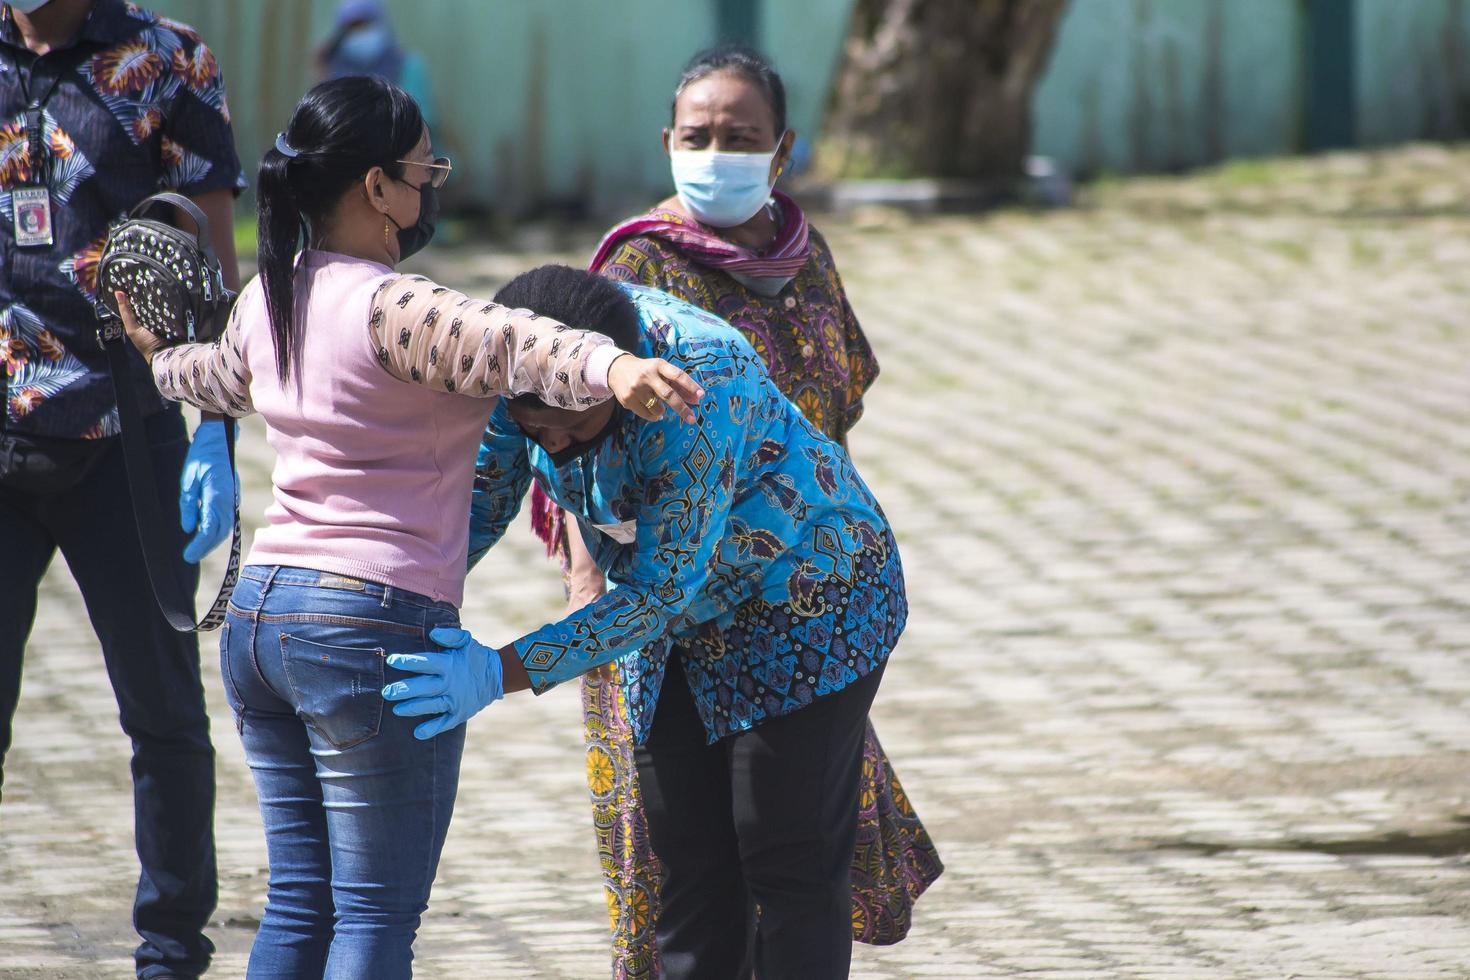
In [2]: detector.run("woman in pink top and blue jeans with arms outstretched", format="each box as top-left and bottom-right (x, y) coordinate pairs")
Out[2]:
(119, 78), (703, 979)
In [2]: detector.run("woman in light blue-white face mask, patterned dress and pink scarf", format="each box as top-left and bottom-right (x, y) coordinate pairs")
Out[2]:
(532, 47), (942, 977)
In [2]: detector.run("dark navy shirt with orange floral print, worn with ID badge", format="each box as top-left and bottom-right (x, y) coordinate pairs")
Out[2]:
(0, 0), (245, 439)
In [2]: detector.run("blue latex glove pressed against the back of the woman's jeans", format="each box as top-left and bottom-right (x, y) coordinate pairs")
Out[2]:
(382, 626), (506, 739)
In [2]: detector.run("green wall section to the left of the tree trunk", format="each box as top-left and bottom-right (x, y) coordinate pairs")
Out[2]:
(143, 0), (853, 212)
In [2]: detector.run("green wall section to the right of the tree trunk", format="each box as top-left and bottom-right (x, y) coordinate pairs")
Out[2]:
(1033, 0), (1470, 173)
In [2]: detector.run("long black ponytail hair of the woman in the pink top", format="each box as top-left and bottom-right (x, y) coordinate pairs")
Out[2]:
(256, 76), (423, 383)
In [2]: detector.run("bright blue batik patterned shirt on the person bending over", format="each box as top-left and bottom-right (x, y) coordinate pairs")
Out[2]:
(470, 285), (908, 742)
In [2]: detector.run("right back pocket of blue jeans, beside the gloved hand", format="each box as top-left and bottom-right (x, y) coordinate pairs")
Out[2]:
(281, 633), (385, 749)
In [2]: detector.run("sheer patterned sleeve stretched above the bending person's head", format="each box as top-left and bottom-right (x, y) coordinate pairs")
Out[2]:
(369, 276), (622, 410)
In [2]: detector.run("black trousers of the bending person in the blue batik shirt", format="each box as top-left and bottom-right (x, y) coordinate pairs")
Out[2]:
(635, 652), (882, 980)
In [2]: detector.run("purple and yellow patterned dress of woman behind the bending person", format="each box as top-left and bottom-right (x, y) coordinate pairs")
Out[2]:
(552, 197), (944, 980)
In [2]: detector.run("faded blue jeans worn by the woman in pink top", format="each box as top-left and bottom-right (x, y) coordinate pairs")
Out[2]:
(221, 566), (465, 980)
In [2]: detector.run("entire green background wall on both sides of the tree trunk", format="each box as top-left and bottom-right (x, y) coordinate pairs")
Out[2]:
(146, 0), (1470, 199)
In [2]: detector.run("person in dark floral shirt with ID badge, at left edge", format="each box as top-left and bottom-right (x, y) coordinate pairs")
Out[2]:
(0, 0), (244, 980)
